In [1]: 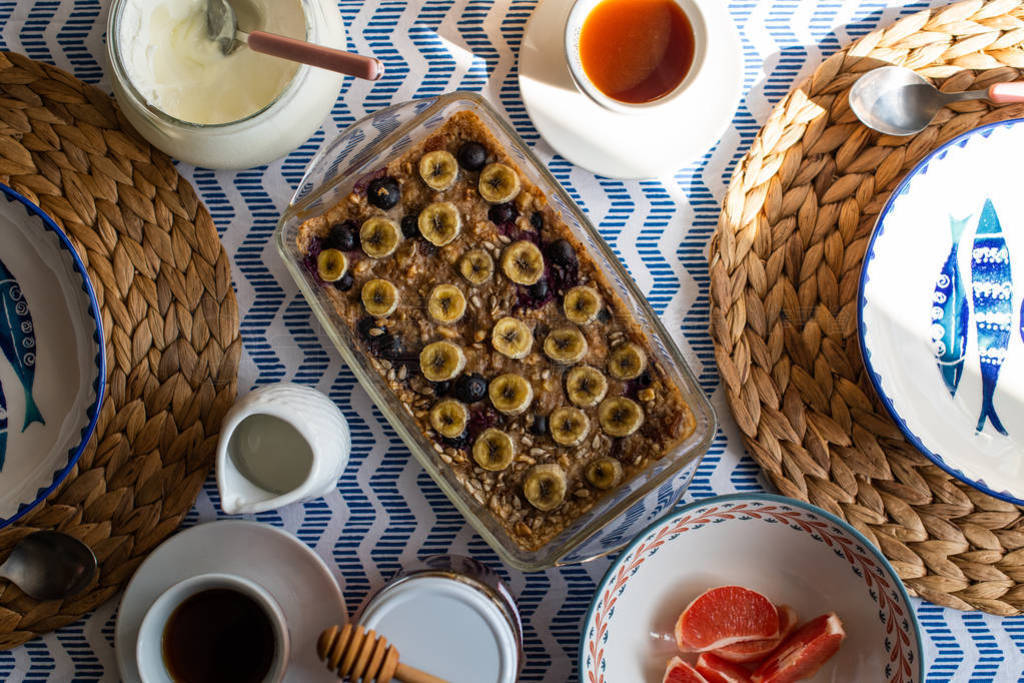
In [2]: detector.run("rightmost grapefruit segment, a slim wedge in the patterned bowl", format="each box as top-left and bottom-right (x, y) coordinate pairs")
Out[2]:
(751, 612), (846, 683)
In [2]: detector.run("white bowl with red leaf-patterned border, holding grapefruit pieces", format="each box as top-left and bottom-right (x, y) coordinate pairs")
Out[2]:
(580, 494), (925, 683)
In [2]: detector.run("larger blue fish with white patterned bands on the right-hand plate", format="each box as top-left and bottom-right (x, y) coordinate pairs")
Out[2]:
(971, 200), (1014, 434)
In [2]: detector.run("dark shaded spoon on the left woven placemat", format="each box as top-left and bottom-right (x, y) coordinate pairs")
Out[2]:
(0, 531), (96, 600)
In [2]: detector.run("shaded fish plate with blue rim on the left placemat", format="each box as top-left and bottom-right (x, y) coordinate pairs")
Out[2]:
(0, 185), (106, 527)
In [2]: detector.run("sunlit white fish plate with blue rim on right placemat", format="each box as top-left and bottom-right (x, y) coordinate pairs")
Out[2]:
(859, 120), (1024, 504)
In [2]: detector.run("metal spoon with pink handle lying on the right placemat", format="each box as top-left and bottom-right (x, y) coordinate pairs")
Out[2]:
(850, 67), (1024, 135)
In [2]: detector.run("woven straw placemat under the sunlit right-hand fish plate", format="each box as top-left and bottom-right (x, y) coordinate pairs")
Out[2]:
(711, 0), (1024, 615)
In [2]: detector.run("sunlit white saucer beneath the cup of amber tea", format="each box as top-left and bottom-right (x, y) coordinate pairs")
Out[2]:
(519, 0), (743, 179)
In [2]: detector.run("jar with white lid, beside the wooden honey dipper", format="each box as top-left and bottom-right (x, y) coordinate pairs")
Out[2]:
(359, 555), (523, 683)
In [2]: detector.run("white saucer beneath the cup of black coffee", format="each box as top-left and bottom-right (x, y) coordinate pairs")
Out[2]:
(116, 520), (348, 683)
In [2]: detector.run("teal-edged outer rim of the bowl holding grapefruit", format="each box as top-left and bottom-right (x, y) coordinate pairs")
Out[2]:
(577, 493), (925, 683)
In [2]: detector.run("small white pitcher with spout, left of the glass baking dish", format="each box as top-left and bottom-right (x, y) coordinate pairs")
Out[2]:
(217, 383), (351, 515)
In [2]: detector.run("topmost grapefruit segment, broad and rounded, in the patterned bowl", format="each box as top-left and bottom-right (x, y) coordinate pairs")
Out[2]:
(676, 586), (779, 652)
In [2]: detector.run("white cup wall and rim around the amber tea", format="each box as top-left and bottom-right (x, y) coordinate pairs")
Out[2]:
(565, 0), (708, 114)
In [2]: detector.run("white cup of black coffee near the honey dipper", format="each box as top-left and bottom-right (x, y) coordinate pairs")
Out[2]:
(135, 573), (290, 683)
